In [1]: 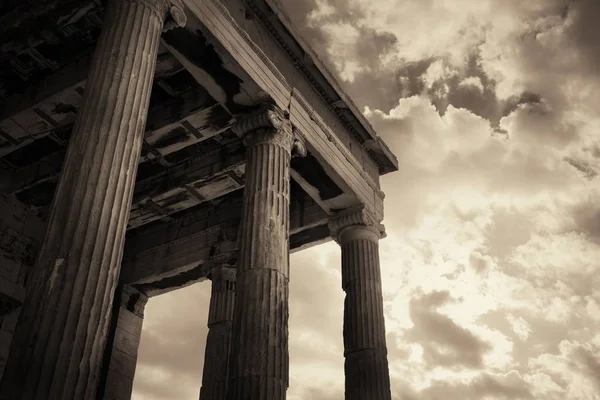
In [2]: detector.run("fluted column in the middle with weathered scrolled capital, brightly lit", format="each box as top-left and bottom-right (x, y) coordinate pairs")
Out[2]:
(228, 107), (303, 400)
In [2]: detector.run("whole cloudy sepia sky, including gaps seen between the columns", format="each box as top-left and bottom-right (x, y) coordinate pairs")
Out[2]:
(134, 0), (600, 400)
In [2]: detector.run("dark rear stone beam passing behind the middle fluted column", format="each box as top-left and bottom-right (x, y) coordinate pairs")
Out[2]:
(120, 184), (330, 296)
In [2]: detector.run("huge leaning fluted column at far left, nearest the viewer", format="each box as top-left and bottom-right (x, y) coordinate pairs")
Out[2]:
(0, 0), (185, 400)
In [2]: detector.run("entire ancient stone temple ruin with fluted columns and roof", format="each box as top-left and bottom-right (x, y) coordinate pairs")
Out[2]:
(0, 0), (397, 400)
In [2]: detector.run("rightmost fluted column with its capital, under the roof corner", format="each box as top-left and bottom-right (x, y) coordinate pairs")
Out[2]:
(329, 210), (392, 400)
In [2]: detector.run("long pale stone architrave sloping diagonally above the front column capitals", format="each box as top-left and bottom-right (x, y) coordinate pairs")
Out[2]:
(177, 0), (383, 220)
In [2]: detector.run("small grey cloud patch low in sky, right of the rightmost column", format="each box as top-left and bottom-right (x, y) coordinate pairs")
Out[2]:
(405, 292), (491, 368)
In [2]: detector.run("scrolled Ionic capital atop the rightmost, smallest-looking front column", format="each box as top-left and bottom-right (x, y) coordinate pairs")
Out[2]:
(329, 206), (385, 244)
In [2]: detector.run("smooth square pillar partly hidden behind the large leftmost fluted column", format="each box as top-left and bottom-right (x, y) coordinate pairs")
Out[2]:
(98, 285), (148, 400)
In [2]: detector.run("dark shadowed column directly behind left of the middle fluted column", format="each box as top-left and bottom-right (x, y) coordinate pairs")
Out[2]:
(200, 267), (236, 400)
